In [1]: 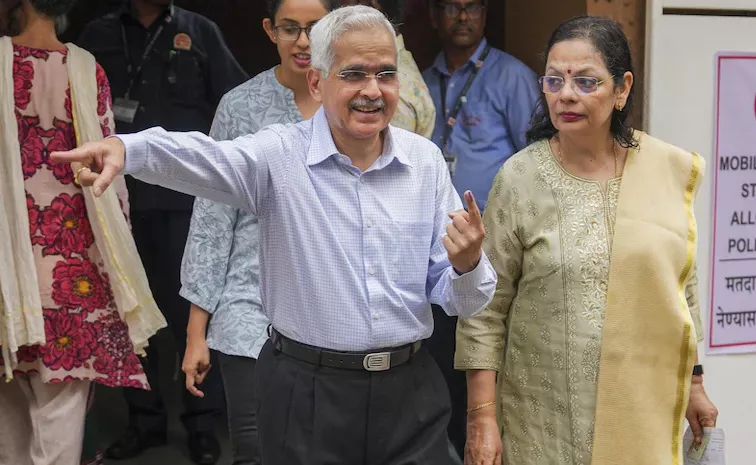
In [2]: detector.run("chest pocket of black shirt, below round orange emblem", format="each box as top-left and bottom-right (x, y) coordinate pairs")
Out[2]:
(165, 50), (206, 105)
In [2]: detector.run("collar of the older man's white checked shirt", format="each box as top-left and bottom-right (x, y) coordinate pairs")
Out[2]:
(307, 106), (412, 169)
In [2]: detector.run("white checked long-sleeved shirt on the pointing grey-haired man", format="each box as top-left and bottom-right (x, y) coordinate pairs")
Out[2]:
(118, 108), (496, 351)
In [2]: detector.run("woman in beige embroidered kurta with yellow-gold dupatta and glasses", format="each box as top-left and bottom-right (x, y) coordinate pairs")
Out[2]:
(455, 17), (717, 465)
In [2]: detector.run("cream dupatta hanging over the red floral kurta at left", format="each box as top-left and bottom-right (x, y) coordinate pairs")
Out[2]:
(0, 37), (166, 380)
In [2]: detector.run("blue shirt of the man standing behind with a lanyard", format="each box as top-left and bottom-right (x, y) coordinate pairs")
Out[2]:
(423, 39), (540, 209)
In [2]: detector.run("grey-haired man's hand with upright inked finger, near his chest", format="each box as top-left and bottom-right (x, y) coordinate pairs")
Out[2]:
(443, 191), (486, 274)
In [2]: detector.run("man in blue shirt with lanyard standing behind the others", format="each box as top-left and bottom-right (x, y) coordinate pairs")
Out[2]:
(423, 0), (539, 456)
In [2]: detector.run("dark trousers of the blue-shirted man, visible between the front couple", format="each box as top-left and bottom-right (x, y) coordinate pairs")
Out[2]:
(425, 305), (467, 458)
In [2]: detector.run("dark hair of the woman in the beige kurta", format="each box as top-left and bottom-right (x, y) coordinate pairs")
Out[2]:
(527, 16), (637, 147)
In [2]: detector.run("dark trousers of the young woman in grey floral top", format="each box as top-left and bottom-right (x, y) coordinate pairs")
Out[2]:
(218, 352), (260, 465)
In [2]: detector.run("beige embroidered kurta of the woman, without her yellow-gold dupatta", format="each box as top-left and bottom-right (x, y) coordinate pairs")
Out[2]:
(455, 141), (703, 465)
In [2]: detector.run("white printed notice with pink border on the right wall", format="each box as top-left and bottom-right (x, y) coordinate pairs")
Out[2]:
(699, 53), (756, 354)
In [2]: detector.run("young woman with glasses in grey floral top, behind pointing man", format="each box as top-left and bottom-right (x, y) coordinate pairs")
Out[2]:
(181, 0), (331, 465)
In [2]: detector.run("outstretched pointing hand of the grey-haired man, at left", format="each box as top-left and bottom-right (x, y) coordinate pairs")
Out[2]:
(50, 137), (126, 197)
